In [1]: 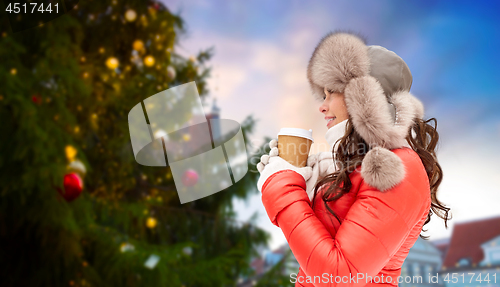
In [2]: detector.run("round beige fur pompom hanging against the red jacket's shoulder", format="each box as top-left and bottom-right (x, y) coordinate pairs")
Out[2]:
(361, 147), (406, 191)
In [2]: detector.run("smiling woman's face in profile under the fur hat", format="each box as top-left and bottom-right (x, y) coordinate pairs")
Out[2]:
(319, 88), (349, 128)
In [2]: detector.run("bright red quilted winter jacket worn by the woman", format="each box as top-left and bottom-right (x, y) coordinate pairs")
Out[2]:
(262, 148), (431, 287)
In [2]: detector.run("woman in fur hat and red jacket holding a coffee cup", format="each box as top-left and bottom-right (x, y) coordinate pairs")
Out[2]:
(257, 32), (451, 286)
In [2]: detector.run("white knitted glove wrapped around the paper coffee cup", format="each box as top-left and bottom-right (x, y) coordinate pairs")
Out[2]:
(257, 139), (314, 198)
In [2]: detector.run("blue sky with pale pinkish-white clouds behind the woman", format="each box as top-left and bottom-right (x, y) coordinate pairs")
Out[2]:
(164, 0), (500, 251)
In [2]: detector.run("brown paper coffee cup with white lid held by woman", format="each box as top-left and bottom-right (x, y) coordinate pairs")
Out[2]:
(278, 128), (314, 167)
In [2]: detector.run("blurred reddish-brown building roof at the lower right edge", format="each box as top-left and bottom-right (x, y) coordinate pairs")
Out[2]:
(443, 216), (500, 269)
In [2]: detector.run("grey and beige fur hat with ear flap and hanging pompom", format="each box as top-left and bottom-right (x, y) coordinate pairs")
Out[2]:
(307, 32), (424, 191)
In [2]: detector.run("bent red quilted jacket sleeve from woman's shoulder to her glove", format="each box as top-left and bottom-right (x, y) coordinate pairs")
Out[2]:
(262, 152), (429, 286)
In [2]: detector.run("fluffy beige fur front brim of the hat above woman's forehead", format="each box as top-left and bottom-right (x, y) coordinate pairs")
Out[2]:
(307, 32), (370, 99)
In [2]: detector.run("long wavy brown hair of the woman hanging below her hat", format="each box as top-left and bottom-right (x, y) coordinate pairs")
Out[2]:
(313, 118), (451, 239)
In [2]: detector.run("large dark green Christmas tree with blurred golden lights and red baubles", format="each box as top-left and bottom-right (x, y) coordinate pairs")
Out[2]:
(0, 0), (269, 287)
